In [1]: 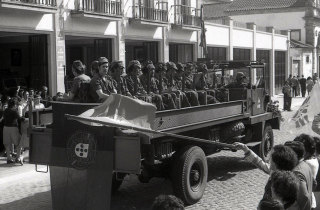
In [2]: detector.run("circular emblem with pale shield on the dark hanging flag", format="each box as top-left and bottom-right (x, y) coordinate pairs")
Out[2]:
(67, 131), (97, 170)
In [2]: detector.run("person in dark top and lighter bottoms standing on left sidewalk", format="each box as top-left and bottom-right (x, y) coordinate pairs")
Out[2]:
(3, 99), (23, 165)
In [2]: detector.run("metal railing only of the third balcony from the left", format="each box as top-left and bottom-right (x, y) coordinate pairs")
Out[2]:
(133, 2), (168, 22)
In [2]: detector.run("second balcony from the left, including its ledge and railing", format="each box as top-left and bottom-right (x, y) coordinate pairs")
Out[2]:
(72, 0), (122, 20)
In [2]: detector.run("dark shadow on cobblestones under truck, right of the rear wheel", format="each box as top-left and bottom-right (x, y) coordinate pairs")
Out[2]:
(208, 156), (256, 182)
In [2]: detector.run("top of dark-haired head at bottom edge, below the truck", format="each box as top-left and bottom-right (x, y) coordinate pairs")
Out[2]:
(152, 195), (184, 210)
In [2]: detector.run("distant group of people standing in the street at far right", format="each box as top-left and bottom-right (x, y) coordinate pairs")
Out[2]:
(282, 73), (318, 111)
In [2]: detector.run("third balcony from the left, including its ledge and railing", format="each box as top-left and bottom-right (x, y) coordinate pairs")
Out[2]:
(131, 1), (168, 26)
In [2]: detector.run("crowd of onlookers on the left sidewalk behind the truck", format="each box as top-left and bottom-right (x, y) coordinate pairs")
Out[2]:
(0, 86), (52, 165)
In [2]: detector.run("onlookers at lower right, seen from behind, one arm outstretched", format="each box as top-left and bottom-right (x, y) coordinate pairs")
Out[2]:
(234, 134), (320, 210)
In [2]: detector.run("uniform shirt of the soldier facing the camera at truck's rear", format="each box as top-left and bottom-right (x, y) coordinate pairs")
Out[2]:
(90, 76), (117, 102)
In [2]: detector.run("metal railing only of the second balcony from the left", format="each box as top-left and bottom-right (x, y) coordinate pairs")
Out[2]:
(75, 0), (122, 16)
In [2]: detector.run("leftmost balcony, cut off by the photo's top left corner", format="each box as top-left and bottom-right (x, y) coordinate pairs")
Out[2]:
(0, 0), (57, 13)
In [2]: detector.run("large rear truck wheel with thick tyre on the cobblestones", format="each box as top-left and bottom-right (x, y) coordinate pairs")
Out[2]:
(172, 146), (208, 205)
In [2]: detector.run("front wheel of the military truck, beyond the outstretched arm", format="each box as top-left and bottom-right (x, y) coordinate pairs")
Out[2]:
(259, 124), (274, 161)
